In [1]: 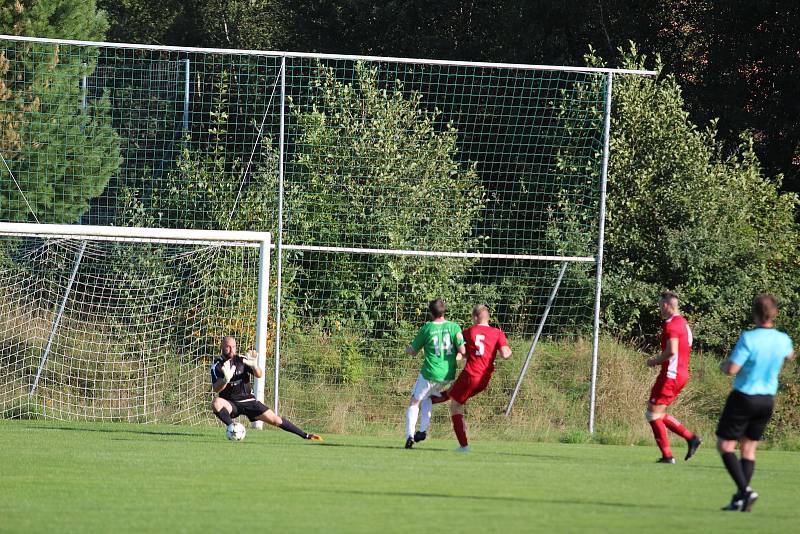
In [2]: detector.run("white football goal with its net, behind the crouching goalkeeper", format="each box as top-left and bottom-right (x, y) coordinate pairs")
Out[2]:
(0, 223), (272, 428)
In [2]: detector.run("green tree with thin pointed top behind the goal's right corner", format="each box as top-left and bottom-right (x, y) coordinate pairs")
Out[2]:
(118, 73), (282, 346)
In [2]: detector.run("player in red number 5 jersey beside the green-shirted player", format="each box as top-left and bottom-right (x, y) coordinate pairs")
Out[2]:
(433, 304), (511, 452)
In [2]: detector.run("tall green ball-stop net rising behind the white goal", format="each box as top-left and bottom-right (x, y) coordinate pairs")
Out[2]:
(0, 38), (607, 438)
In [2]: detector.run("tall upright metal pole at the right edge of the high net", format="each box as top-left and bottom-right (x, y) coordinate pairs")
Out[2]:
(589, 72), (614, 434)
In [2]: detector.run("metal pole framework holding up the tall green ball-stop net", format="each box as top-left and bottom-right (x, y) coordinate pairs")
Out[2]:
(0, 35), (657, 434)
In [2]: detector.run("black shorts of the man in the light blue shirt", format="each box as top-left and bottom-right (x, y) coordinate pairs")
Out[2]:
(717, 390), (775, 441)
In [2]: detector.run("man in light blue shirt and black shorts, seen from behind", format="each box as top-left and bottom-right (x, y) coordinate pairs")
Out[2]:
(717, 293), (794, 512)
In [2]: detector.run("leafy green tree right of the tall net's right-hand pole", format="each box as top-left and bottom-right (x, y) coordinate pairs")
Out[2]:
(589, 47), (800, 350)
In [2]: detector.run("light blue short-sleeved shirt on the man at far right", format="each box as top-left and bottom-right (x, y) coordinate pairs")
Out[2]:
(730, 328), (792, 395)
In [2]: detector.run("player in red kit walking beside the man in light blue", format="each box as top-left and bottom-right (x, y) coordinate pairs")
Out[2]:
(645, 291), (703, 464)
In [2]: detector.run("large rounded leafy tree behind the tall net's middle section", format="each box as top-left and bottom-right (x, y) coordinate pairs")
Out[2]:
(286, 63), (483, 332)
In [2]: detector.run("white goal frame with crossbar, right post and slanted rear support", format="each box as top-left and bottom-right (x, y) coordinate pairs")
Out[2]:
(0, 222), (278, 429)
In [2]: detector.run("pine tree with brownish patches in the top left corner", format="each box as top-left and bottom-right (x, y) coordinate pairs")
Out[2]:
(0, 0), (120, 223)
